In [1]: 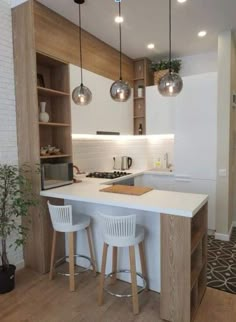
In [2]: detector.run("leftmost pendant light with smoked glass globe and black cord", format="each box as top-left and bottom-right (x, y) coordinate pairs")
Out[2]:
(72, 0), (92, 106)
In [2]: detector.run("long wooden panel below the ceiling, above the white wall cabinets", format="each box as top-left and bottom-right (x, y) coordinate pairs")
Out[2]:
(34, 1), (133, 83)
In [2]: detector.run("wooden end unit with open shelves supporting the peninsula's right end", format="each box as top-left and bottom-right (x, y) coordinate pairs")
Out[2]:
(161, 203), (208, 322)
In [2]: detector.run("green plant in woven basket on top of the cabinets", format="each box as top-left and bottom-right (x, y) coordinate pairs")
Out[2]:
(151, 59), (182, 85)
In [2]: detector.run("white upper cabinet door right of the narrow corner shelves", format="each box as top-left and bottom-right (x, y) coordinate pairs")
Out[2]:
(146, 86), (175, 134)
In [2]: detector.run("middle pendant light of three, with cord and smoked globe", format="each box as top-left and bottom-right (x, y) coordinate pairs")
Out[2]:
(110, 0), (131, 102)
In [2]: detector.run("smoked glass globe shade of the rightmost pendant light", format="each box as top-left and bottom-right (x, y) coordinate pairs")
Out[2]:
(158, 72), (183, 96)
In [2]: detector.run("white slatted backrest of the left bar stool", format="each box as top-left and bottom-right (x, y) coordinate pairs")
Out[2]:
(48, 201), (72, 231)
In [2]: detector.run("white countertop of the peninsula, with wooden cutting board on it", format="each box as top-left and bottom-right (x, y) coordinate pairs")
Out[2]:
(40, 170), (208, 217)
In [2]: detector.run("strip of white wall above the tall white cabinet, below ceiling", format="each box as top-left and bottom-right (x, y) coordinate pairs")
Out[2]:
(180, 52), (218, 76)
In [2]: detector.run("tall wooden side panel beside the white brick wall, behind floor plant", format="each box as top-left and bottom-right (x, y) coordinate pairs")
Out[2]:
(12, 1), (64, 273)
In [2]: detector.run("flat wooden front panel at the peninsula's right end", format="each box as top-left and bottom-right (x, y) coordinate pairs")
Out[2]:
(160, 214), (191, 322)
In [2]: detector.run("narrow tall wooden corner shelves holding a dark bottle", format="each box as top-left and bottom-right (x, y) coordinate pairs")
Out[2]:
(134, 58), (153, 135)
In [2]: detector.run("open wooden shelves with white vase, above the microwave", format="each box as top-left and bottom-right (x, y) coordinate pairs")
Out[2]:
(36, 53), (72, 163)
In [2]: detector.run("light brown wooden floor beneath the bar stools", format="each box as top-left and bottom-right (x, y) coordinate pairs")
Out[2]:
(0, 269), (236, 322)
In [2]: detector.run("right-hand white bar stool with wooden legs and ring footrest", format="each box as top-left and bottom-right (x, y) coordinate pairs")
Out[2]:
(98, 215), (147, 314)
